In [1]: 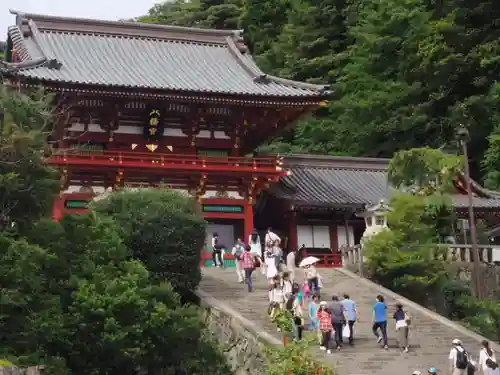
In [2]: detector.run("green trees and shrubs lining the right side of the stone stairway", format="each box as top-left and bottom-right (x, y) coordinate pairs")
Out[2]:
(364, 148), (500, 341)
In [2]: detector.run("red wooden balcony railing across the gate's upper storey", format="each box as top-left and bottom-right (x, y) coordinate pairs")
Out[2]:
(47, 149), (285, 175)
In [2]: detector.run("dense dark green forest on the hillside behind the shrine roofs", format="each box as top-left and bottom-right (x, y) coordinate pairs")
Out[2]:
(139, 0), (500, 187)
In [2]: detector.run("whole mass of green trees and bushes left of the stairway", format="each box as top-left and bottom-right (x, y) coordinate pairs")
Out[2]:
(0, 91), (231, 375)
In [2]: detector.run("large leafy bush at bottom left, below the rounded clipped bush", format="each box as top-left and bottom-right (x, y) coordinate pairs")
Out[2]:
(17, 213), (230, 375)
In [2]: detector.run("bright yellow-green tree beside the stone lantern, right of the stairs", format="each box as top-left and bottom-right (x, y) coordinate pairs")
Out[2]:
(364, 193), (451, 303)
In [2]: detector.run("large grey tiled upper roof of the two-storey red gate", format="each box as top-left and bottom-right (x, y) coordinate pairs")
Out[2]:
(3, 12), (329, 99)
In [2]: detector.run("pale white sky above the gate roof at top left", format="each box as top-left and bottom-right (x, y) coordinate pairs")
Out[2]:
(0, 0), (161, 40)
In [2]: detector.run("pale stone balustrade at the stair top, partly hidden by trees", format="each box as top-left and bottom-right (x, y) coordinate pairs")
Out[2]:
(340, 244), (500, 266)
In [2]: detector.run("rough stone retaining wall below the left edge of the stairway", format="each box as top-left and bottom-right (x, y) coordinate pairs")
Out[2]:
(197, 291), (281, 375)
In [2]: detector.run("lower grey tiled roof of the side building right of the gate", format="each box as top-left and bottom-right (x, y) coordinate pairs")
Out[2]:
(270, 155), (500, 208)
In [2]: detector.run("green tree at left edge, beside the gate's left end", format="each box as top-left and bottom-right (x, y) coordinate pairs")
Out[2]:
(0, 87), (59, 229)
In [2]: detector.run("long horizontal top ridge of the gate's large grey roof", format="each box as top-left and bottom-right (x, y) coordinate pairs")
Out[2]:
(10, 9), (242, 43)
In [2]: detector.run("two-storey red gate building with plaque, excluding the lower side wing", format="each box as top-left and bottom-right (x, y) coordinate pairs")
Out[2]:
(2, 12), (329, 264)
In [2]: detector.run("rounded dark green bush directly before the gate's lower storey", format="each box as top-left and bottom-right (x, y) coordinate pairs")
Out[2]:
(93, 189), (206, 295)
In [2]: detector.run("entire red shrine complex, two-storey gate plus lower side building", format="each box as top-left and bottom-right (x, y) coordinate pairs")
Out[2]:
(5, 12), (500, 265)
